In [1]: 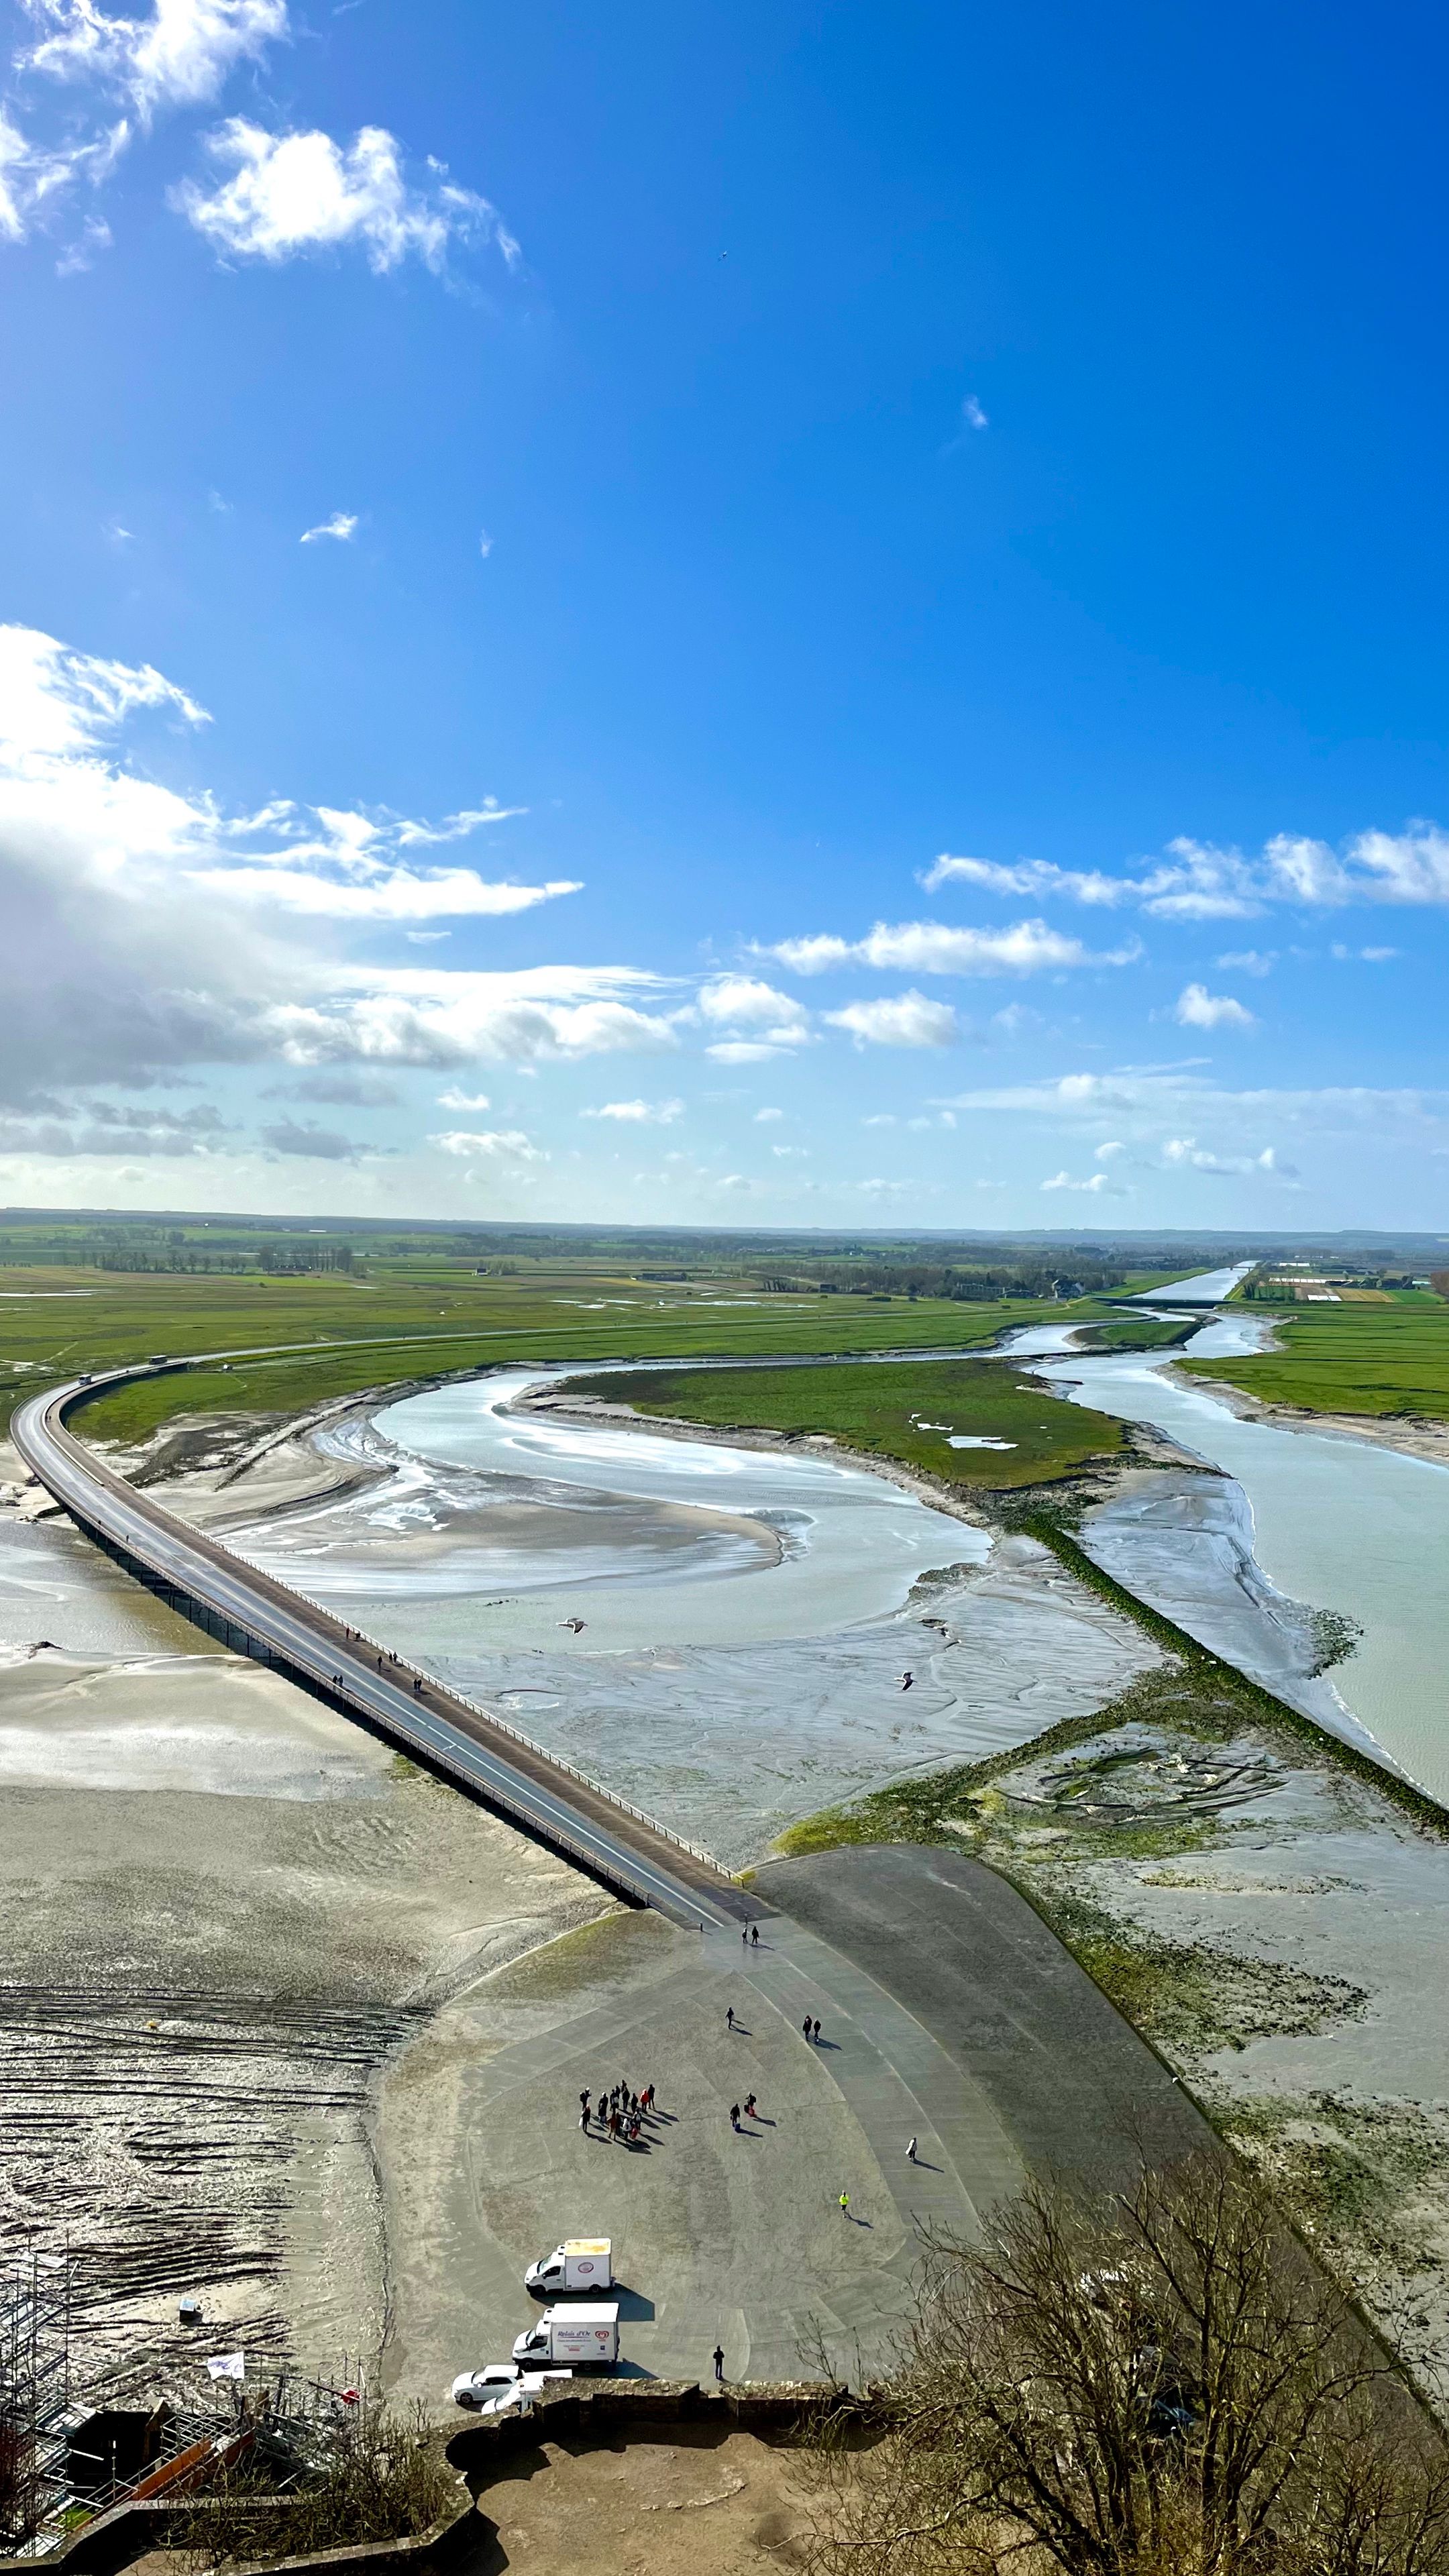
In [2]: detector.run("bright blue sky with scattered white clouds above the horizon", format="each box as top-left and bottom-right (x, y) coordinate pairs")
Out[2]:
(0, 0), (1449, 1232)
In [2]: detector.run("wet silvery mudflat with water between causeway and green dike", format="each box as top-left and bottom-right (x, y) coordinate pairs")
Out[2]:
(147, 1371), (1155, 1868)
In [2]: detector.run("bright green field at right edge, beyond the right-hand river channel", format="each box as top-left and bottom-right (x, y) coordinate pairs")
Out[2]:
(1191, 1288), (1449, 1422)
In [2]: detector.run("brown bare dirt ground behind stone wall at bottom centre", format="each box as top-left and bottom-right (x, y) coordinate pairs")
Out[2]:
(477, 2424), (810, 2576)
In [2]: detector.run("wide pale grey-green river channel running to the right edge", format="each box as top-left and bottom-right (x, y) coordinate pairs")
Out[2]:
(1044, 1316), (1449, 1798)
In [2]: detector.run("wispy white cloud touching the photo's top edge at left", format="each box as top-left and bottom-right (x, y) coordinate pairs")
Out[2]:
(21, 0), (286, 116)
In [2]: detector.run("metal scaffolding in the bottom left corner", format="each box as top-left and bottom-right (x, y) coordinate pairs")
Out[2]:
(0, 2254), (72, 2553)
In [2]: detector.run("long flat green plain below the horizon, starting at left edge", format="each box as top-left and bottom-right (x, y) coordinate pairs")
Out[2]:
(0, 1254), (1155, 1440)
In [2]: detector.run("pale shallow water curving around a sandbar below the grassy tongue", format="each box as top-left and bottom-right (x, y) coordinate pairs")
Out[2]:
(232, 1368), (990, 1649)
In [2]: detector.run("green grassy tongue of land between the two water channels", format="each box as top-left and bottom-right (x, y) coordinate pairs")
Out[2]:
(568, 1360), (1127, 1491)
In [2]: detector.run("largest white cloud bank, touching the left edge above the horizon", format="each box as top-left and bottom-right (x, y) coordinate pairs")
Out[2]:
(0, 626), (678, 1128)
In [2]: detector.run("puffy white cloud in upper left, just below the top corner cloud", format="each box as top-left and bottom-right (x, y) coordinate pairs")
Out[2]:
(170, 116), (519, 276)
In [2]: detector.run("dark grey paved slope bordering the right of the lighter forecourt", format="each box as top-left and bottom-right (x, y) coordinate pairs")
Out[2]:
(753, 1842), (1217, 2190)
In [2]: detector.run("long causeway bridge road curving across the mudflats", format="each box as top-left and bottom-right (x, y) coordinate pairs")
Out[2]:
(10, 1371), (748, 1924)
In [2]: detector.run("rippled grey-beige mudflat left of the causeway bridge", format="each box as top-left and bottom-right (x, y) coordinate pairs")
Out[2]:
(0, 1452), (606, 2385)
